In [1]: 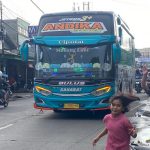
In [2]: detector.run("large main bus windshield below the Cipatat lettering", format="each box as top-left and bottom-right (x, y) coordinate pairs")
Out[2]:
(35, 44), (114, 79)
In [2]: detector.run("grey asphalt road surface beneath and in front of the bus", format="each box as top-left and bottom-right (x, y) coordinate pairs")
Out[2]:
(0, 94), (147, 150)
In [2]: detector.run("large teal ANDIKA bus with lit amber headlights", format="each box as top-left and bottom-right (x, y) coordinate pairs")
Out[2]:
(20, 11), (135, 112)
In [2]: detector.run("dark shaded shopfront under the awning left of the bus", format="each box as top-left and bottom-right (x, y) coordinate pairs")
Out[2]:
(0, 54), (34, 90)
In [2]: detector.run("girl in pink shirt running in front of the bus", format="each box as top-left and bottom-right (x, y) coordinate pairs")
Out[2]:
(93, 95), (137, 150)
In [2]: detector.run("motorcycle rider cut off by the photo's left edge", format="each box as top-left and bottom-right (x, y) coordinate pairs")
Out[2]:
(0, 71), (8, 105)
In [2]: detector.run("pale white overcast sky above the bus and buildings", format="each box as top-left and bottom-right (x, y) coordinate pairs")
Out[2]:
(2, 0), (150, 49)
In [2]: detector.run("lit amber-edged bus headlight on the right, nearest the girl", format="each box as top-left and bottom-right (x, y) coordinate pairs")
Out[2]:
(91, 85), (111, 96)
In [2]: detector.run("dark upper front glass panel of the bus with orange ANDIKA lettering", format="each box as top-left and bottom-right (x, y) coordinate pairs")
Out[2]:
(38, 13), (114, 36)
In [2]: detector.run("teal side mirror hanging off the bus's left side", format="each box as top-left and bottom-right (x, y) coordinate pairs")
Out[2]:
(19, 40), (29, 61)
